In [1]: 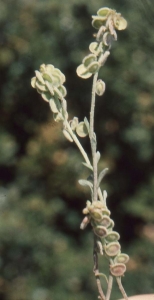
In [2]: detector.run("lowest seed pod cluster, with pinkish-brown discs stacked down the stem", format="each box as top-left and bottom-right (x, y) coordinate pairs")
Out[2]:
(81, 197), (129, 276)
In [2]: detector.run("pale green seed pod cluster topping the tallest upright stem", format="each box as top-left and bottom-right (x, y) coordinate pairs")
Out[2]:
(77, 7), (127, 79)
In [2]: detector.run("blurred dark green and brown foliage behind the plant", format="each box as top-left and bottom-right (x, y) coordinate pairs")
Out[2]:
(0, 0), (154, 300)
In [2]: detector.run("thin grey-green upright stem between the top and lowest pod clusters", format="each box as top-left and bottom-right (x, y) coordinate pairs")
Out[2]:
(89, 72), (98, 201)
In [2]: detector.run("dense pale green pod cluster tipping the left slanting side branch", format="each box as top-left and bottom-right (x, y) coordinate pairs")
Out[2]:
(31, 64), (66, 122)
